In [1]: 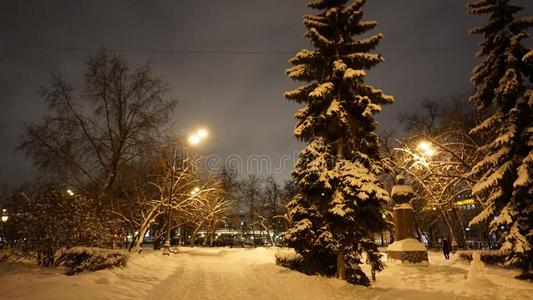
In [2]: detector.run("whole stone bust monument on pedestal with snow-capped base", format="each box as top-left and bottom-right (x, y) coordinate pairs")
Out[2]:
(387, 175), (428, 265)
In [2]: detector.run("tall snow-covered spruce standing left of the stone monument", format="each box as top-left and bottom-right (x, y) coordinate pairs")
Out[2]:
(283, 0), (394, 286)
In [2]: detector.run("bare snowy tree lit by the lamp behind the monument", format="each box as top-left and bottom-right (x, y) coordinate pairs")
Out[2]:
(382, 99), (479, 246)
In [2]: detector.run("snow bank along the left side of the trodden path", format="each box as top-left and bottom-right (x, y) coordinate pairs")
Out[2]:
(0, 250), (183, 300)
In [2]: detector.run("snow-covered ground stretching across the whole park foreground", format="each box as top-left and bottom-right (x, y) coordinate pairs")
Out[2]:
(0, 248), (533, 300)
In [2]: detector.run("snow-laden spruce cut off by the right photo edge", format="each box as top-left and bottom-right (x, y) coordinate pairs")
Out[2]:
(468, 0), (533, 277)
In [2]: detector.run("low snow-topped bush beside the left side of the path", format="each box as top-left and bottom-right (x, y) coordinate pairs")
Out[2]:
(57, 247), (129, 275)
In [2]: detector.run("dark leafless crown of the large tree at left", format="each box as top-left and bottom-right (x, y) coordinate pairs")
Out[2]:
(19, 50), (176, 206)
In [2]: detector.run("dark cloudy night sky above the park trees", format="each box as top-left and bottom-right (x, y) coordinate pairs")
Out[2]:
(0, 0), (532, 184)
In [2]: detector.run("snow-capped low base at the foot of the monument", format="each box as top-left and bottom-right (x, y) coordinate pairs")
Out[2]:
(387, 238), (429, 266)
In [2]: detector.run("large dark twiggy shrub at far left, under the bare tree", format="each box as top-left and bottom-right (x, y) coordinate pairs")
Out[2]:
(2, 183), (112, 267)
